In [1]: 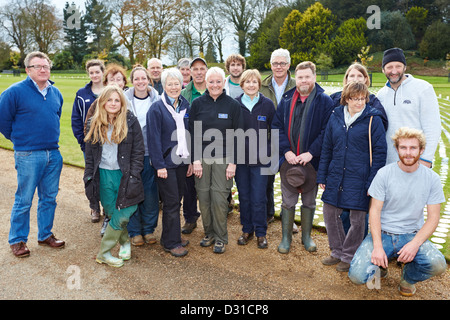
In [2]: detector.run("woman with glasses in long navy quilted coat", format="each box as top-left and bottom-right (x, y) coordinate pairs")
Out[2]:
(317, 82), (387, 271)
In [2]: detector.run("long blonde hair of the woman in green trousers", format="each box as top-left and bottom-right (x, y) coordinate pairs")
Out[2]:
(84, 84), (128, 144)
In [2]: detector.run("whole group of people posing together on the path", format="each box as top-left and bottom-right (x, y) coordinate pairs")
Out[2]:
(0, 48), (446, 295)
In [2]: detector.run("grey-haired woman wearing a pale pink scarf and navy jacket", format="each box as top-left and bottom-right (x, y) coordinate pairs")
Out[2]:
(147, 68), (192, 257)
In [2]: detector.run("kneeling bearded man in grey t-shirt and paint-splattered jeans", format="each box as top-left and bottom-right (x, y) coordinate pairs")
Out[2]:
(349, 127), (447, 296)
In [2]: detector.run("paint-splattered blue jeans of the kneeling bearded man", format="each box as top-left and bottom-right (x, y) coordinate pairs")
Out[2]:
(348, 232), (447, 284)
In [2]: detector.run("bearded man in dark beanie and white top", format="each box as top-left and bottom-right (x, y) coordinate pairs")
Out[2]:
(377, 48), (441, 168)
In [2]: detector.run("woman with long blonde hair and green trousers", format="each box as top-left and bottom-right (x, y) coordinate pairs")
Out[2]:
(84, 84), (145, 267)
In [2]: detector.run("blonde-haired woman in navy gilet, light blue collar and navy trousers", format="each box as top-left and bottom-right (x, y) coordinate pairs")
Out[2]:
(235, 70), (275, 249)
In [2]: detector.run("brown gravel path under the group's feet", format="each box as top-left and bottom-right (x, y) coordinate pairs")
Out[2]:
(0, 149), (450, 300)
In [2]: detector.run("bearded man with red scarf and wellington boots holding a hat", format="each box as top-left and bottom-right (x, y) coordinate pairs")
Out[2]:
(272, 61), (333, 253)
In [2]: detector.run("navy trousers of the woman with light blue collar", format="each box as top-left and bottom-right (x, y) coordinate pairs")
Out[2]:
(234, 164), (269, 237)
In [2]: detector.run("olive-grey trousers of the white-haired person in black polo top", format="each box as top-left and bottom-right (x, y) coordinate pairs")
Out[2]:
(195, 160), (233, 244)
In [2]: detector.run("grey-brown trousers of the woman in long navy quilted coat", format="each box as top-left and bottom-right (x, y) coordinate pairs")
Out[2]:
(323, 203), (366, 263)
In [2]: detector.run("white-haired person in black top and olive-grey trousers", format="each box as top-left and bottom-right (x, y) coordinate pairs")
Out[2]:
(189, 67), (243, 253)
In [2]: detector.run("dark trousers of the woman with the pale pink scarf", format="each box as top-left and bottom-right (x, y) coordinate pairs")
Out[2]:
(156, 166), (188, 249)
